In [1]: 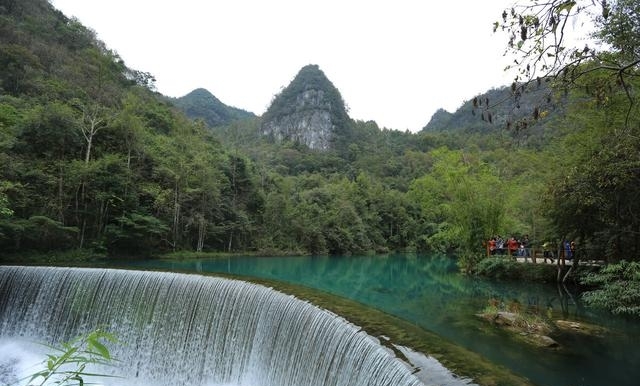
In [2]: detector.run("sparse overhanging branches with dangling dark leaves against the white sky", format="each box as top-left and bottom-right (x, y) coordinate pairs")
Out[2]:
(494, 0), (640, 81)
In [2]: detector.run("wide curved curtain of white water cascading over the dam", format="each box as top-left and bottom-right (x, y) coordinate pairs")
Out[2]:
(0, 267), (430, 386)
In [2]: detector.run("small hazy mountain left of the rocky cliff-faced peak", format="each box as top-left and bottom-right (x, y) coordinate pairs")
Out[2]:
(171, 88), (255, 127)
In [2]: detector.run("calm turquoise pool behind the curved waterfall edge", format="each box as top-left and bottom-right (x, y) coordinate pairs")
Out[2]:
(116, 255), (640, 386)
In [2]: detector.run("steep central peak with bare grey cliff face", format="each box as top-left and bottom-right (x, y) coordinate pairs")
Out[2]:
(261, 65), (351, 150)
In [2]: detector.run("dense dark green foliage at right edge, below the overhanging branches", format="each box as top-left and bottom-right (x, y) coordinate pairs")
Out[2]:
(547, 77), (640, 261)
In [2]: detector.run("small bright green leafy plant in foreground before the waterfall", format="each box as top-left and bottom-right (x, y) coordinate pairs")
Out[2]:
(27, 329), (117, 386)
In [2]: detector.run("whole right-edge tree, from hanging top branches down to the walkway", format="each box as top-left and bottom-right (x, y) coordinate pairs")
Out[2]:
(494, 0), (640, 260)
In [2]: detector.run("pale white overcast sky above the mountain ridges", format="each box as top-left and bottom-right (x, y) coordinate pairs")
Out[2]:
(51, 0), (513, 132)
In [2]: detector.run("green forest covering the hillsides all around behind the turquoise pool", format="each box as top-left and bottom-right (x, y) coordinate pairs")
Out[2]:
(0, 0), (640, 286)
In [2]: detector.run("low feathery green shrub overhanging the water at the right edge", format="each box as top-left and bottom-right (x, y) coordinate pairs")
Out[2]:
(581, 260), (640, 317)
